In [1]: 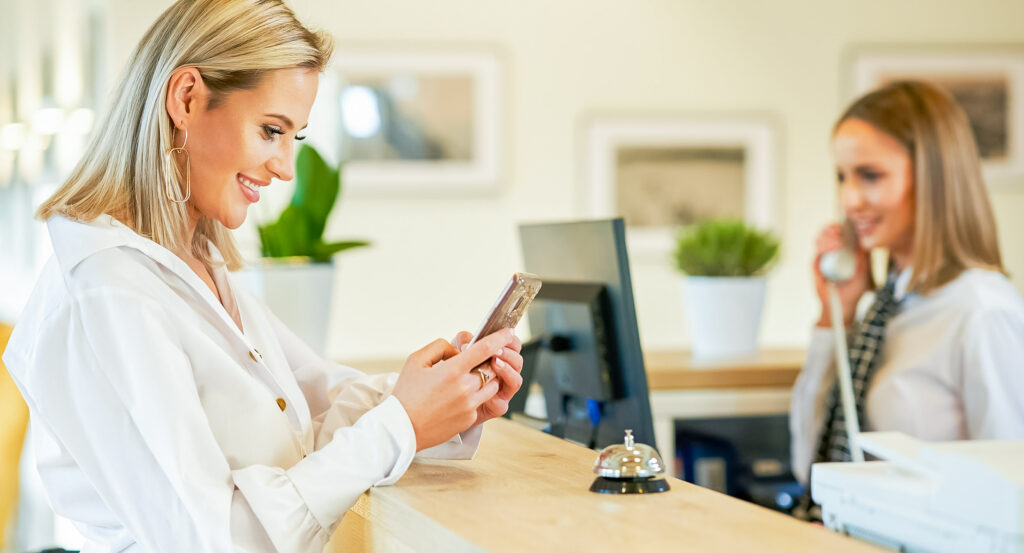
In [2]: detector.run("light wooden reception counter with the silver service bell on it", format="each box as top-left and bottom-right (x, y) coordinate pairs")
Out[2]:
(326, 419), (879, 553)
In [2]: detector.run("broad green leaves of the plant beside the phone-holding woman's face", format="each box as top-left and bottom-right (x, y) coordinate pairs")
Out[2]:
(259, 144), (370, 262)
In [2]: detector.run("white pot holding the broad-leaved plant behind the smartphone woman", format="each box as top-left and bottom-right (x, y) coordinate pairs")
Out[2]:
(238, 258), (336, 355)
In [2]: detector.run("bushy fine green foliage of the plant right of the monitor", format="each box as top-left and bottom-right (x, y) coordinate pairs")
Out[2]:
(675, 220), (778, 277)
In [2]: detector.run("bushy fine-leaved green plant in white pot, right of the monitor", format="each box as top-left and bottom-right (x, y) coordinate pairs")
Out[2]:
(675, 220), (778, 358)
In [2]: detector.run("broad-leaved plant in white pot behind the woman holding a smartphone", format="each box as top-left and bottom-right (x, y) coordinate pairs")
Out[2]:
(242, 144), (369, 354)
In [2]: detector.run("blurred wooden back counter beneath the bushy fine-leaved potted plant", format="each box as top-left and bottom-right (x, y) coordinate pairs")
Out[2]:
(351, 349), (805, 468)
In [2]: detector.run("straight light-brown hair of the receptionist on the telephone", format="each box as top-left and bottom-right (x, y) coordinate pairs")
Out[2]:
(835, 81), (1005, 294)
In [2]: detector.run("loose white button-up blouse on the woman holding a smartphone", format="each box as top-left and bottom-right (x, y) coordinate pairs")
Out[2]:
(3, 216), (480, 553)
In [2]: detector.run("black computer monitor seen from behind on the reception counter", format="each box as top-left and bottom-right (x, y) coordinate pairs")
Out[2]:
(513, 218), (654, 448)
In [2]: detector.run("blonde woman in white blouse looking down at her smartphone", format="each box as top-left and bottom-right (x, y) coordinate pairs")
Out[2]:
(4, 0), (522, 553)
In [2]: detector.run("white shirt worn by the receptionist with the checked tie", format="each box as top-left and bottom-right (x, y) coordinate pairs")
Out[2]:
(790, 269), (1024, 482)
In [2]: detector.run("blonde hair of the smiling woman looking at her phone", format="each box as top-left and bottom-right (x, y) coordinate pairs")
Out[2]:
(36, 0), (332, 270)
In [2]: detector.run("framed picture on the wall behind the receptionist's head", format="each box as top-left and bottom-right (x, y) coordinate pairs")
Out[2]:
(848, 45), (1024, 180)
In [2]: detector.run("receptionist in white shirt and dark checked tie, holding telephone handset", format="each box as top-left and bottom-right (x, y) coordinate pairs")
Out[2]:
(791, 82), (1024, 505)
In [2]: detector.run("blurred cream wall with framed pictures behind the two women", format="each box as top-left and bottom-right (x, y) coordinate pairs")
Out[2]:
(6, 0), (1024, 547)
